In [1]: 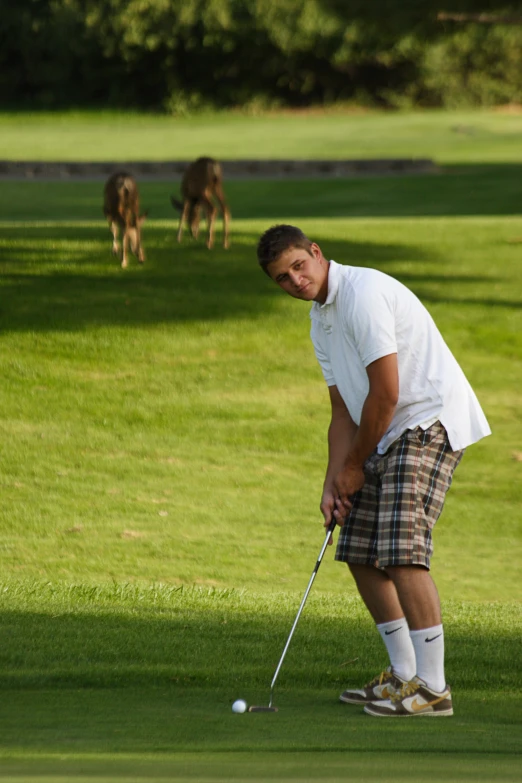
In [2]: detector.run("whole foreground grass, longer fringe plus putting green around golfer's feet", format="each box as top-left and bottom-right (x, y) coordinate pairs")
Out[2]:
(0, 574), (522, 781)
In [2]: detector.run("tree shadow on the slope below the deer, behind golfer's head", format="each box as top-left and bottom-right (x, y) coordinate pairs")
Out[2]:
(0, 225), (502, 332)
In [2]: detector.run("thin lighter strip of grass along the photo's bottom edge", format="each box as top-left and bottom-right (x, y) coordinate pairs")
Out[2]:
(0, 751), (520, 783)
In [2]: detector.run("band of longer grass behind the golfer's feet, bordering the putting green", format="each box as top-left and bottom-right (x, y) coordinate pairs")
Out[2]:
(0, 584), (522, 696)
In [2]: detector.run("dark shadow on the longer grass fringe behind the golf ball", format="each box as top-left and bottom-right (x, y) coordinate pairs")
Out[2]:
(0, 598), (522, 692)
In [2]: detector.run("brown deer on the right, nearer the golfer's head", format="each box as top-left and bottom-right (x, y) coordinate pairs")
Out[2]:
(170, 158), (230, 250)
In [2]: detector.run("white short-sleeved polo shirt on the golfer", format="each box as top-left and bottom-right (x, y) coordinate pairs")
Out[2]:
(310, 261), (491, 454)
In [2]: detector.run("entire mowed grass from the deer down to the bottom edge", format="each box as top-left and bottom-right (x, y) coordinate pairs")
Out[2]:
(0, 110), (522, 783)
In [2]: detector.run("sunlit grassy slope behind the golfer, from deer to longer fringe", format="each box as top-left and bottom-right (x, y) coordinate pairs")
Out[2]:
(0, 178), (522, 600)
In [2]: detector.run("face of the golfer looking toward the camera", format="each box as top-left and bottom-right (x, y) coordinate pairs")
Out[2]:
(268, 242), (328, 304)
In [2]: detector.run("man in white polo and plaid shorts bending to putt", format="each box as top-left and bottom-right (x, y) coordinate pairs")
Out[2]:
(257, 225), (490, 717)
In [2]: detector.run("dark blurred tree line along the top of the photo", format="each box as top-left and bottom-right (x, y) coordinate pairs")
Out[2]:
(0, 0), (522, 114)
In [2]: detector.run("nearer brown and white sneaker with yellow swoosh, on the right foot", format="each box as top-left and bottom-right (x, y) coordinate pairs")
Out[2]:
(364, 677), (453, 718)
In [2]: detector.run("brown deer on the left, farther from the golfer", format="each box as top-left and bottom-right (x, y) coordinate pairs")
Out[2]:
(103, 171), (147, 269)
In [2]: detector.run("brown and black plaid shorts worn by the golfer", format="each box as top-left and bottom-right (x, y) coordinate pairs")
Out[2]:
(335, 421), (464, 568)
